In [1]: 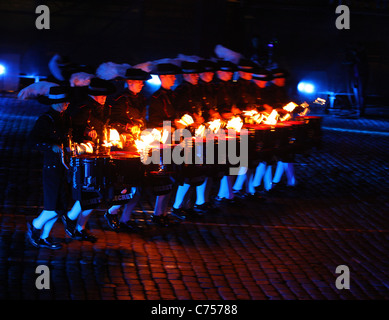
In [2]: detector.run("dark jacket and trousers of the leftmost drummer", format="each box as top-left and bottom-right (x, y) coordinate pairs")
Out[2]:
(29, 107), (69, 214)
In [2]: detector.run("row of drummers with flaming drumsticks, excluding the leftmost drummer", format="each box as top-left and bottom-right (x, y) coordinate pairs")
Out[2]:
(64, 59), (320, 233)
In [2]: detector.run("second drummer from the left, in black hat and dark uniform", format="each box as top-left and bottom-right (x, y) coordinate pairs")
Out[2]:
(62, 78), (115, 242)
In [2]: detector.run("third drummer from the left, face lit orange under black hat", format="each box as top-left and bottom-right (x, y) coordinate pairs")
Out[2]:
(104, 68), (151, 231)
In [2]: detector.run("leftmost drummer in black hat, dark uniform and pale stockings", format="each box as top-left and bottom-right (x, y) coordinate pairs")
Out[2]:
(27, 86), (69, 249)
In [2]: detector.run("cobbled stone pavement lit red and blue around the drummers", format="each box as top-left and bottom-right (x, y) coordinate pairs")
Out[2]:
(0, 95), (389, 300)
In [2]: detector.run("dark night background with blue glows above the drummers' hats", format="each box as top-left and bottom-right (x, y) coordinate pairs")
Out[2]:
(0, 0), (389, 99)
